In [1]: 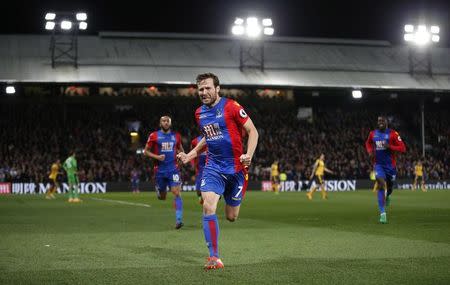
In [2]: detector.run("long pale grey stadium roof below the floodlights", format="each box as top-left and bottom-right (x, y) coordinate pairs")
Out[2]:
(0, 32), (450, 90)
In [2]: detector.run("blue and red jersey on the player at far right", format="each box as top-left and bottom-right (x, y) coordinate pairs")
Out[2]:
(366, 129), (406, 168)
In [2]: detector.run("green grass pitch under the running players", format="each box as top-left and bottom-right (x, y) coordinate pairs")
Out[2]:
(0, 191), (450, 285)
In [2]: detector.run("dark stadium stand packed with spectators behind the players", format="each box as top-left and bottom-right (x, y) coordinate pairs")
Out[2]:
(0, 92), (450, 182)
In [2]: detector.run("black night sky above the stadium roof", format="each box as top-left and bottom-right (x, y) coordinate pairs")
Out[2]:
(0, 0), (450, 46)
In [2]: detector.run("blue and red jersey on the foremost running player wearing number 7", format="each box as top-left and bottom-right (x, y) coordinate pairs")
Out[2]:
(195, 98), (248, 174)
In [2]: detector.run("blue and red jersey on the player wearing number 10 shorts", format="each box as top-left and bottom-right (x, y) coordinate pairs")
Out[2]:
(147, 130), (181, 174)
